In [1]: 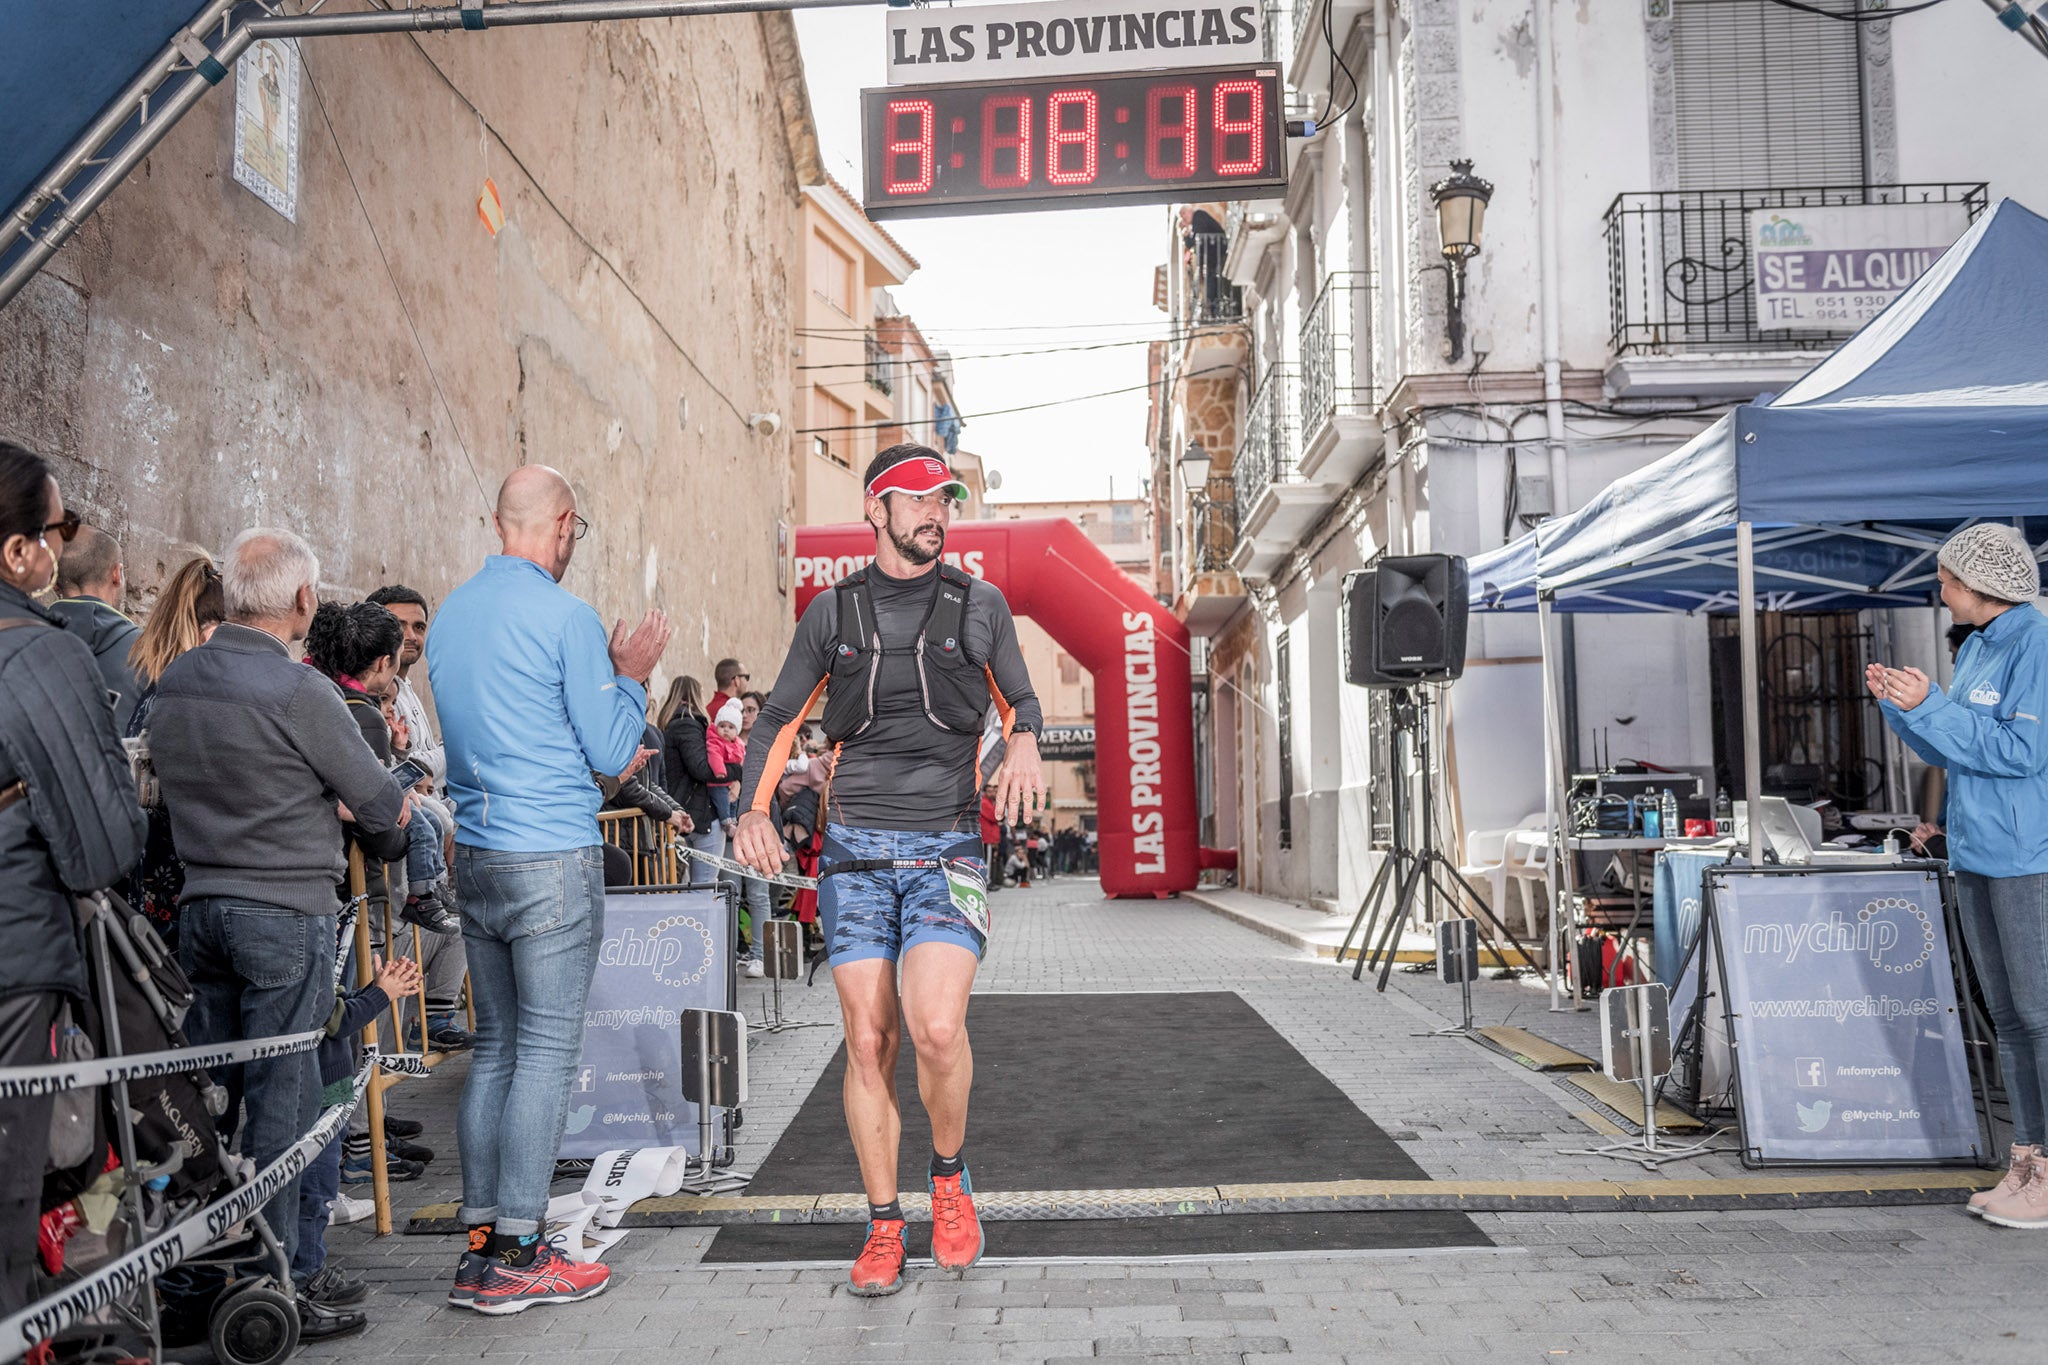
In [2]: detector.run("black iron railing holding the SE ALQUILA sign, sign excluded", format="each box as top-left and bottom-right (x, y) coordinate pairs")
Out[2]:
(1608, 184), (1991, 354)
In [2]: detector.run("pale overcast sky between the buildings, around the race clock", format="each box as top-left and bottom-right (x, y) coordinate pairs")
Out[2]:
(797, 6), (1169, 501)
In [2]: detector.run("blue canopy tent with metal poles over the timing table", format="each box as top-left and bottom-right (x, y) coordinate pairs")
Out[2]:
(1470, 199), (2048, 1002)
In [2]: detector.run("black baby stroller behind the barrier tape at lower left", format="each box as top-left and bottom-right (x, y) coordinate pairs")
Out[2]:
(32, 892), (299, 1365)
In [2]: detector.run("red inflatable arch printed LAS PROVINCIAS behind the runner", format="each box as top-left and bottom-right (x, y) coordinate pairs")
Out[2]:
(797, 518), (1202, 896)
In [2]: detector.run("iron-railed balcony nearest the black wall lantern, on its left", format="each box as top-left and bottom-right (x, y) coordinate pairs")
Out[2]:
(1300, 270), (1384, 485)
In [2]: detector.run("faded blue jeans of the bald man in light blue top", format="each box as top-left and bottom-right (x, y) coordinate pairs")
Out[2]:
(455, 843), (604, 1236)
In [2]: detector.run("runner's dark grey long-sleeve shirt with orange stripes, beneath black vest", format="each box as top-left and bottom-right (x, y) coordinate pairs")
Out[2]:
(739, 569), (1044, 831)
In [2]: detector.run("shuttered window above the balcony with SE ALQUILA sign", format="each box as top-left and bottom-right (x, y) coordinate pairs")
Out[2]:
(1671, 0), (1864, 190)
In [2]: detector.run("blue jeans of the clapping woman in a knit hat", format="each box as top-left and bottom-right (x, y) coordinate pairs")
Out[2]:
(1956, 872), (2048, 1146)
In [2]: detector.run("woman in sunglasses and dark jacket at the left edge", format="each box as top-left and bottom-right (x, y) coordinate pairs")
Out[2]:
(0, 442), (143, 1318)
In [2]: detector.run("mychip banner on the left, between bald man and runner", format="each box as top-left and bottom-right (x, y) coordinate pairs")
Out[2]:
(561, 886), (735, 1156)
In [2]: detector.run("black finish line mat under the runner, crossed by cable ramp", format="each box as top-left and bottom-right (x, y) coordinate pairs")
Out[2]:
(705, 990), (1491, 1263)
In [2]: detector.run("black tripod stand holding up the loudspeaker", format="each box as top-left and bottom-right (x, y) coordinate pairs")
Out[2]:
(1337, 688), (1534, 990)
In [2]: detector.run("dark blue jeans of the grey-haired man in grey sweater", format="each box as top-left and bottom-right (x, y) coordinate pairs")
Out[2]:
(178, 896), (334, 1257)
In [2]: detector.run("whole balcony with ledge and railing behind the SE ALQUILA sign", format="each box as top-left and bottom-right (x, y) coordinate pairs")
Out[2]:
(1606, 184), (1991, 397)
